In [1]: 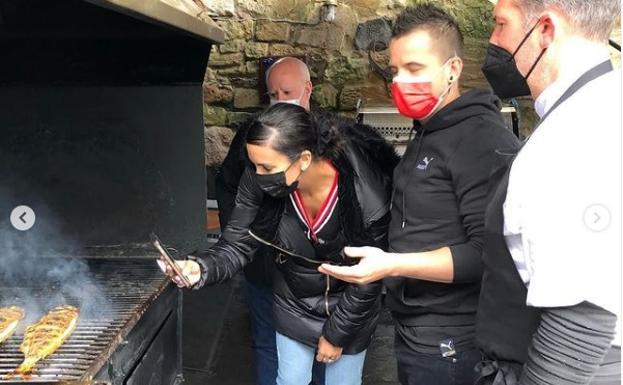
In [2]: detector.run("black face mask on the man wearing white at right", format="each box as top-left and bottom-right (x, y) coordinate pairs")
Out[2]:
(482, 22), (547, 99)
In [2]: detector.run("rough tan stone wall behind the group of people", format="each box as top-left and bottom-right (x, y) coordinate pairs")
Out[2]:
(193, 0), (620, 163)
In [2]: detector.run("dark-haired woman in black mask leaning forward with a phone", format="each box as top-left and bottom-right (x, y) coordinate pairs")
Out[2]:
(161, 103), (398, 385)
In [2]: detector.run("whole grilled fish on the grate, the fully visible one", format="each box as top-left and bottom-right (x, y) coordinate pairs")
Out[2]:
(14, 305), (79, 376)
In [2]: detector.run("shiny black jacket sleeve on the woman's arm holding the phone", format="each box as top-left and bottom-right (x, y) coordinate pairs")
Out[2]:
(191, 168), (269, 289)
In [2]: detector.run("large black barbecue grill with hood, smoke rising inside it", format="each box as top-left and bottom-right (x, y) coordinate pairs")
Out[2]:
(0, 0), (224, 385)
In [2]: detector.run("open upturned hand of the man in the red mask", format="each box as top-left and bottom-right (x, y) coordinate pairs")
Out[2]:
(318, 246), (396, 285)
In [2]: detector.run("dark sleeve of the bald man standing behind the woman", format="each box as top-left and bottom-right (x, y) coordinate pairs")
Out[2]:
(216, 124), (248, 226)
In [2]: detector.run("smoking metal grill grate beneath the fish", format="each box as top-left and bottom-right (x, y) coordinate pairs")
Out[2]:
(0, 259), (168, 384)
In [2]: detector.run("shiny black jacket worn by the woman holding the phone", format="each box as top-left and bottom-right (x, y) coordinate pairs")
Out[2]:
(196, 119), (398, 354)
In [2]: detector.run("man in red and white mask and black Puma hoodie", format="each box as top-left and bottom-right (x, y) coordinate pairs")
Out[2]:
(320, 5), (518, 385)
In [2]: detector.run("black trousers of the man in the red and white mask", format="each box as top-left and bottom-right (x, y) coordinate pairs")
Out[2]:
(395, 335), (482, 385)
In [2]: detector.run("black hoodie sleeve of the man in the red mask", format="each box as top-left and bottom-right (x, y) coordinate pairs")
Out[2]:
(448, 121), (519, 283)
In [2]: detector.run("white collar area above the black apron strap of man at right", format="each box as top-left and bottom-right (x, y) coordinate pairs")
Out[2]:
(534, 52), (609, 118)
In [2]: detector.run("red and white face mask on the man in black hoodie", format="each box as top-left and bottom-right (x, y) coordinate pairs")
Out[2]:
(392, 62), (452, 120)
